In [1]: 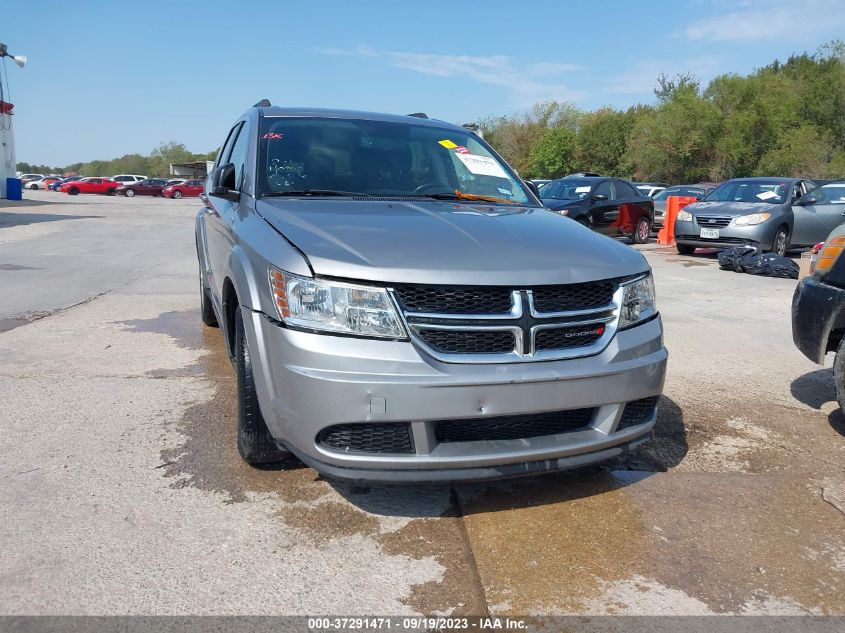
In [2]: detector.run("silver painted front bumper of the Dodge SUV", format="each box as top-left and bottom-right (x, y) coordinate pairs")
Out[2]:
(241, 308), (668, 481)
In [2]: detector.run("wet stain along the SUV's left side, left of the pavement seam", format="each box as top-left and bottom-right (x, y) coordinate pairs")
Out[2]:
(131, 310), (486, 615)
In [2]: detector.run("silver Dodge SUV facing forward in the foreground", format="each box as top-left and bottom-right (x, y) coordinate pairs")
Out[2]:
(196, 101), (667, 481)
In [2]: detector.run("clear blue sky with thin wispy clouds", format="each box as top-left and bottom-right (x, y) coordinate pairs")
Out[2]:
(0, 0), (845, 166)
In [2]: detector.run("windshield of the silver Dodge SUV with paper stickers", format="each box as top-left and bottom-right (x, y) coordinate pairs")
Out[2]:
(258, 117), (529, 204)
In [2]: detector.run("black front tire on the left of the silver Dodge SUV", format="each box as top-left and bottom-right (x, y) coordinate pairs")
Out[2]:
(235, 307), (290, 464)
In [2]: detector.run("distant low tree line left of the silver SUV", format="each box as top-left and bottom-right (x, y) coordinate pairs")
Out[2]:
(18, 141), (217, 176)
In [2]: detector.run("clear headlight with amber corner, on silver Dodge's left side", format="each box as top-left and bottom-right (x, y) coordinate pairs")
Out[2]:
(270, 267), (405, 338)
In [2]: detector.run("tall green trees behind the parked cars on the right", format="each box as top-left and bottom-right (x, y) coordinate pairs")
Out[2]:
(481, 41), (845, 183)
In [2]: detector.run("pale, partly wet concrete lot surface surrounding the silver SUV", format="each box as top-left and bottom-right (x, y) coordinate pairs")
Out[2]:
(0, 191), (845, 615)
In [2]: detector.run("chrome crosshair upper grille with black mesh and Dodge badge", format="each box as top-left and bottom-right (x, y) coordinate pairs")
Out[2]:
(390, 276), (628, 363)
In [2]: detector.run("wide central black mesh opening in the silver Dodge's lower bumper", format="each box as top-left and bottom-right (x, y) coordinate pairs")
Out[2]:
(434, 408), (593, 442)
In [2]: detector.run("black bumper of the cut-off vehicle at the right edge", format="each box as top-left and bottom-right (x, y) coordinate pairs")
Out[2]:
(792, 277), (845, 365)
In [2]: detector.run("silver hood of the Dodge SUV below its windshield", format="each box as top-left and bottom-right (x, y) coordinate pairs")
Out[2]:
(257, 199), (648, 286)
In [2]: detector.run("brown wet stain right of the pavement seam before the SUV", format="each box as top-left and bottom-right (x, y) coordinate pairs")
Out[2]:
(462, 473), (845, 614)
